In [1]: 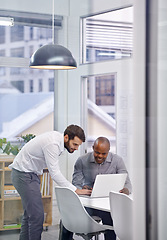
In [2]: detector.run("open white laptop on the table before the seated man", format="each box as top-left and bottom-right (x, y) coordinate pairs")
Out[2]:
(80, 173), (127, 198)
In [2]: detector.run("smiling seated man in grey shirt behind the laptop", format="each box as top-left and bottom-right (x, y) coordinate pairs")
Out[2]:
(59, 137), (132, 240)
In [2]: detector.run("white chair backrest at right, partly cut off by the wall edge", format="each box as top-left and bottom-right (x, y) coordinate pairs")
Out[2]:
(109, 192), (133, 240)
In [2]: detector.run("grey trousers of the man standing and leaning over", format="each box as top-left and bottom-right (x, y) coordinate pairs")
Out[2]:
(11, 169), (44, 240)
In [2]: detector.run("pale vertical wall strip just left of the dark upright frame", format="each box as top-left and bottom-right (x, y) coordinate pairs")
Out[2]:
(131, 0), (146, 240)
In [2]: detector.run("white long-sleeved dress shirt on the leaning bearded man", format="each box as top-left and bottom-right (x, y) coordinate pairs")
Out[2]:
(9, 131), (76, 191)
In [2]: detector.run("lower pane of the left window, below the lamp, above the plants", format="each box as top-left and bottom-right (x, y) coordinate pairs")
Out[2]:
(0, 68), (54, 140)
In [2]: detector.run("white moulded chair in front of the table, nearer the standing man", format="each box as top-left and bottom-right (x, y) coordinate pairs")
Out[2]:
(55, 187), (113, 240)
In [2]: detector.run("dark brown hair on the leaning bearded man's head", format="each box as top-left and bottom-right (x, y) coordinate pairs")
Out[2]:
(64, 124), (85, 142)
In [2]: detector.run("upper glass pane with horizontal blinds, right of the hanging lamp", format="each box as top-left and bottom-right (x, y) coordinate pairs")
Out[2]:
(82, 7), (133, 63)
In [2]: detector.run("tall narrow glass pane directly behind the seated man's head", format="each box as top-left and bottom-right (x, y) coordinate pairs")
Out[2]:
(83, 74), (116, 153)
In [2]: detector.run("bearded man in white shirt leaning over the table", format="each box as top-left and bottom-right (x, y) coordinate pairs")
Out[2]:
(9, 125), (91, 240)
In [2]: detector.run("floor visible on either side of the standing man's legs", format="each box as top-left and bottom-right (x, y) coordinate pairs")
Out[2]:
(0, 225), (59, 240)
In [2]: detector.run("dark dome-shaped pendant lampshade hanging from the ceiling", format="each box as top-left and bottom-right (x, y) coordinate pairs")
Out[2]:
(30, 44), (77, 70)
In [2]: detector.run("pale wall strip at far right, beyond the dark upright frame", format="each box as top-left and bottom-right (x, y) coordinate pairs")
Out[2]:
(155, 0), (167, 240)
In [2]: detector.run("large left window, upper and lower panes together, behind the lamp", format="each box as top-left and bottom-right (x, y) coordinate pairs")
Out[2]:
(0, 10), (63, 140)
